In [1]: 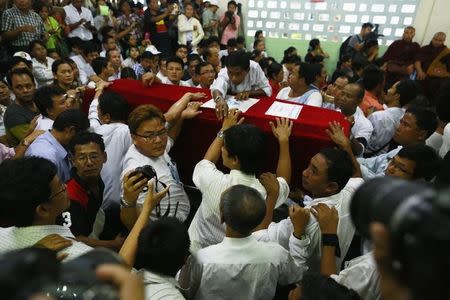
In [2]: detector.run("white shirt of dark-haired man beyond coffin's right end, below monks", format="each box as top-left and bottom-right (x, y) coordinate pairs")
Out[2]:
(367, 107), (405, 154)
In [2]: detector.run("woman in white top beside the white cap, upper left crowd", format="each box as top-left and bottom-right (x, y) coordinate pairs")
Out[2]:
(30, 40), (54, 87)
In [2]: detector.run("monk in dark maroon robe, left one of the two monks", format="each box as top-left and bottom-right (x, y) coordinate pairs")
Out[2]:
(382, 26), (420, 86)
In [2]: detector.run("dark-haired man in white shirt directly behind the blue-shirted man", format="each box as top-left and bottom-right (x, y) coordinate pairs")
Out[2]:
(33, 85), (74, 131)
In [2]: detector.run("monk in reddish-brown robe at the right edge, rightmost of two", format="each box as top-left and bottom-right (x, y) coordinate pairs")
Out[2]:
(414, 32), (450, 102)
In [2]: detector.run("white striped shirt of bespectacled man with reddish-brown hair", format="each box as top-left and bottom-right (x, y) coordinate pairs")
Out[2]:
(120, 143), (190, 221)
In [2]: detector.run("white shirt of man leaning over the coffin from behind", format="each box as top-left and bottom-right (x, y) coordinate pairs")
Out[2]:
(210, 60), (272, 97)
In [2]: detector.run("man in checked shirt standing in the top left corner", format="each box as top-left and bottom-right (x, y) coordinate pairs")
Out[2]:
(1, 0), (45, 55)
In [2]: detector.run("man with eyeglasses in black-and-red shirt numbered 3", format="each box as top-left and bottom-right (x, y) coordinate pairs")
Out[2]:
(63, 132), (124, 250)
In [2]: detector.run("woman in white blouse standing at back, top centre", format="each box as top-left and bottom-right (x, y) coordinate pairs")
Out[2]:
(178, 3), (205, 51)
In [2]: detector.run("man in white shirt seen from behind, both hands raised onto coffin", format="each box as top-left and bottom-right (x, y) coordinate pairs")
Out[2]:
(189, 110), (292, 252)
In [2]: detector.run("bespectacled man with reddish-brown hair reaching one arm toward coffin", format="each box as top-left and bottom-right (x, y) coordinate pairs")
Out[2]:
(121, 93), (206, 229)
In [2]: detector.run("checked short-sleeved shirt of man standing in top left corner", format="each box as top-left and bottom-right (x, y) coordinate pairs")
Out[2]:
(1, 5), (44, 47)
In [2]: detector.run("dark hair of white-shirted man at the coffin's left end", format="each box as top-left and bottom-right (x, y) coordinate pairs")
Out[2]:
(98, 91), (128, 122)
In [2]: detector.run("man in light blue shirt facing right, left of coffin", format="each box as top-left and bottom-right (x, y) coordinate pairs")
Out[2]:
(25, 109), (89, 182)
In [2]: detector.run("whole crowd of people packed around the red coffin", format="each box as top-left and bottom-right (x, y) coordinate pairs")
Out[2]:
(0, 0), (450, 300)
